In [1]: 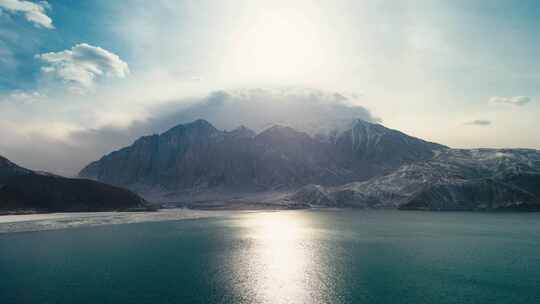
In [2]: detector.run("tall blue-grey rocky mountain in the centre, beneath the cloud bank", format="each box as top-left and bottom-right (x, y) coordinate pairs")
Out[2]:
(80, 120), (446, 198)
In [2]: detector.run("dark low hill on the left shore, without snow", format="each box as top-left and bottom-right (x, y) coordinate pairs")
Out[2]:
(0, 157), (148, 214)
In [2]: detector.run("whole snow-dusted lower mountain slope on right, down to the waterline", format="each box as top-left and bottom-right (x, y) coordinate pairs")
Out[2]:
(292, 149), (540, 210)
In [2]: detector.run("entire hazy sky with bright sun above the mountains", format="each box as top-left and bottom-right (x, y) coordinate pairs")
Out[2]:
(0, 0), (540, 174)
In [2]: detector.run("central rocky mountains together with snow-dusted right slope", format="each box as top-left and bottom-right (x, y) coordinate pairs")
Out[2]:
(79, 119), (540, 210)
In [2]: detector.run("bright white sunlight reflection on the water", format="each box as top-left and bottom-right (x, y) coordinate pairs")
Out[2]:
(234, 212), (320, 303)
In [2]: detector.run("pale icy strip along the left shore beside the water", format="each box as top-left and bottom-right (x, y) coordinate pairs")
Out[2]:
(0, 209), (238, 233)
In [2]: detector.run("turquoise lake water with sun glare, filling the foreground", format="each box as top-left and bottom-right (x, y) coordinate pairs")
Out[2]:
(0, 210), (540, 304)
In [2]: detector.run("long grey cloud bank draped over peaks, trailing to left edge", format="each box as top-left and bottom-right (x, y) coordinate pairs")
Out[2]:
(0, 88), (381, 175)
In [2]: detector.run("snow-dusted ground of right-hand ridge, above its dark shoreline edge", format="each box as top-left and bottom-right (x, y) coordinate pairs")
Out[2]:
(291, 149), (540, 208)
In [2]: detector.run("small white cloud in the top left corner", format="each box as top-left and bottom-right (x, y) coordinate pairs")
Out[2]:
(0, 0), (54, 29)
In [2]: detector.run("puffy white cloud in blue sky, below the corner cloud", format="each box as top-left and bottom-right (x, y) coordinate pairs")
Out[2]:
(36, 43), (129, 87)
